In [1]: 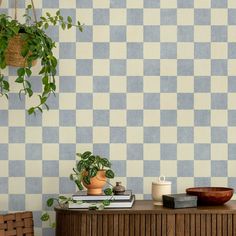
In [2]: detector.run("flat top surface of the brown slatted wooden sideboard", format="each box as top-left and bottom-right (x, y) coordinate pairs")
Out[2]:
(54, 200), (236, 214)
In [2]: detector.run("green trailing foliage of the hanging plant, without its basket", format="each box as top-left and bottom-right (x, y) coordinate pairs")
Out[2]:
(0, 5), (83, 114)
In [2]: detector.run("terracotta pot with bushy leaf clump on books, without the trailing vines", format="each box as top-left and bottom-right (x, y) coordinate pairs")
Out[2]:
(70, 151), (115, 195)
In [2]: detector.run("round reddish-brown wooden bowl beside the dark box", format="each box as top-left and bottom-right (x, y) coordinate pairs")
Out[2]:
(186, 187), (234, 205)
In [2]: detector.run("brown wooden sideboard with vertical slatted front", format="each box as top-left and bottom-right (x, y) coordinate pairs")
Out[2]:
(55, 200), (236, 236)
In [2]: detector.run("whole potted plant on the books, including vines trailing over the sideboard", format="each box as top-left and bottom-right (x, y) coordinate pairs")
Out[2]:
(41, 151), (115, 228)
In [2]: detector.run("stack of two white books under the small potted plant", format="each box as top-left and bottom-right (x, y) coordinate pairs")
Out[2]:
(68, 190), (135, 209)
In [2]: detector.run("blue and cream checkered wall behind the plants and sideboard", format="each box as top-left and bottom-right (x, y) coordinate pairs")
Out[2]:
(0, 0), (236, 235)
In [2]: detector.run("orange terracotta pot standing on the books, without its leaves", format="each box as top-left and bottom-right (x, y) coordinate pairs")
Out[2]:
(83, 170), (106, 195)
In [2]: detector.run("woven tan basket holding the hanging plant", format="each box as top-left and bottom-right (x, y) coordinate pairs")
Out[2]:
(5, 34), (37, 67)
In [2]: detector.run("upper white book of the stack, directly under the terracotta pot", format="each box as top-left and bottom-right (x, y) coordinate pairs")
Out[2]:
(72, 190), (132, 201)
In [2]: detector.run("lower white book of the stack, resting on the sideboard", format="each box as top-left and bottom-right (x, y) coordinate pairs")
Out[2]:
(68, 195), (135, 209)
